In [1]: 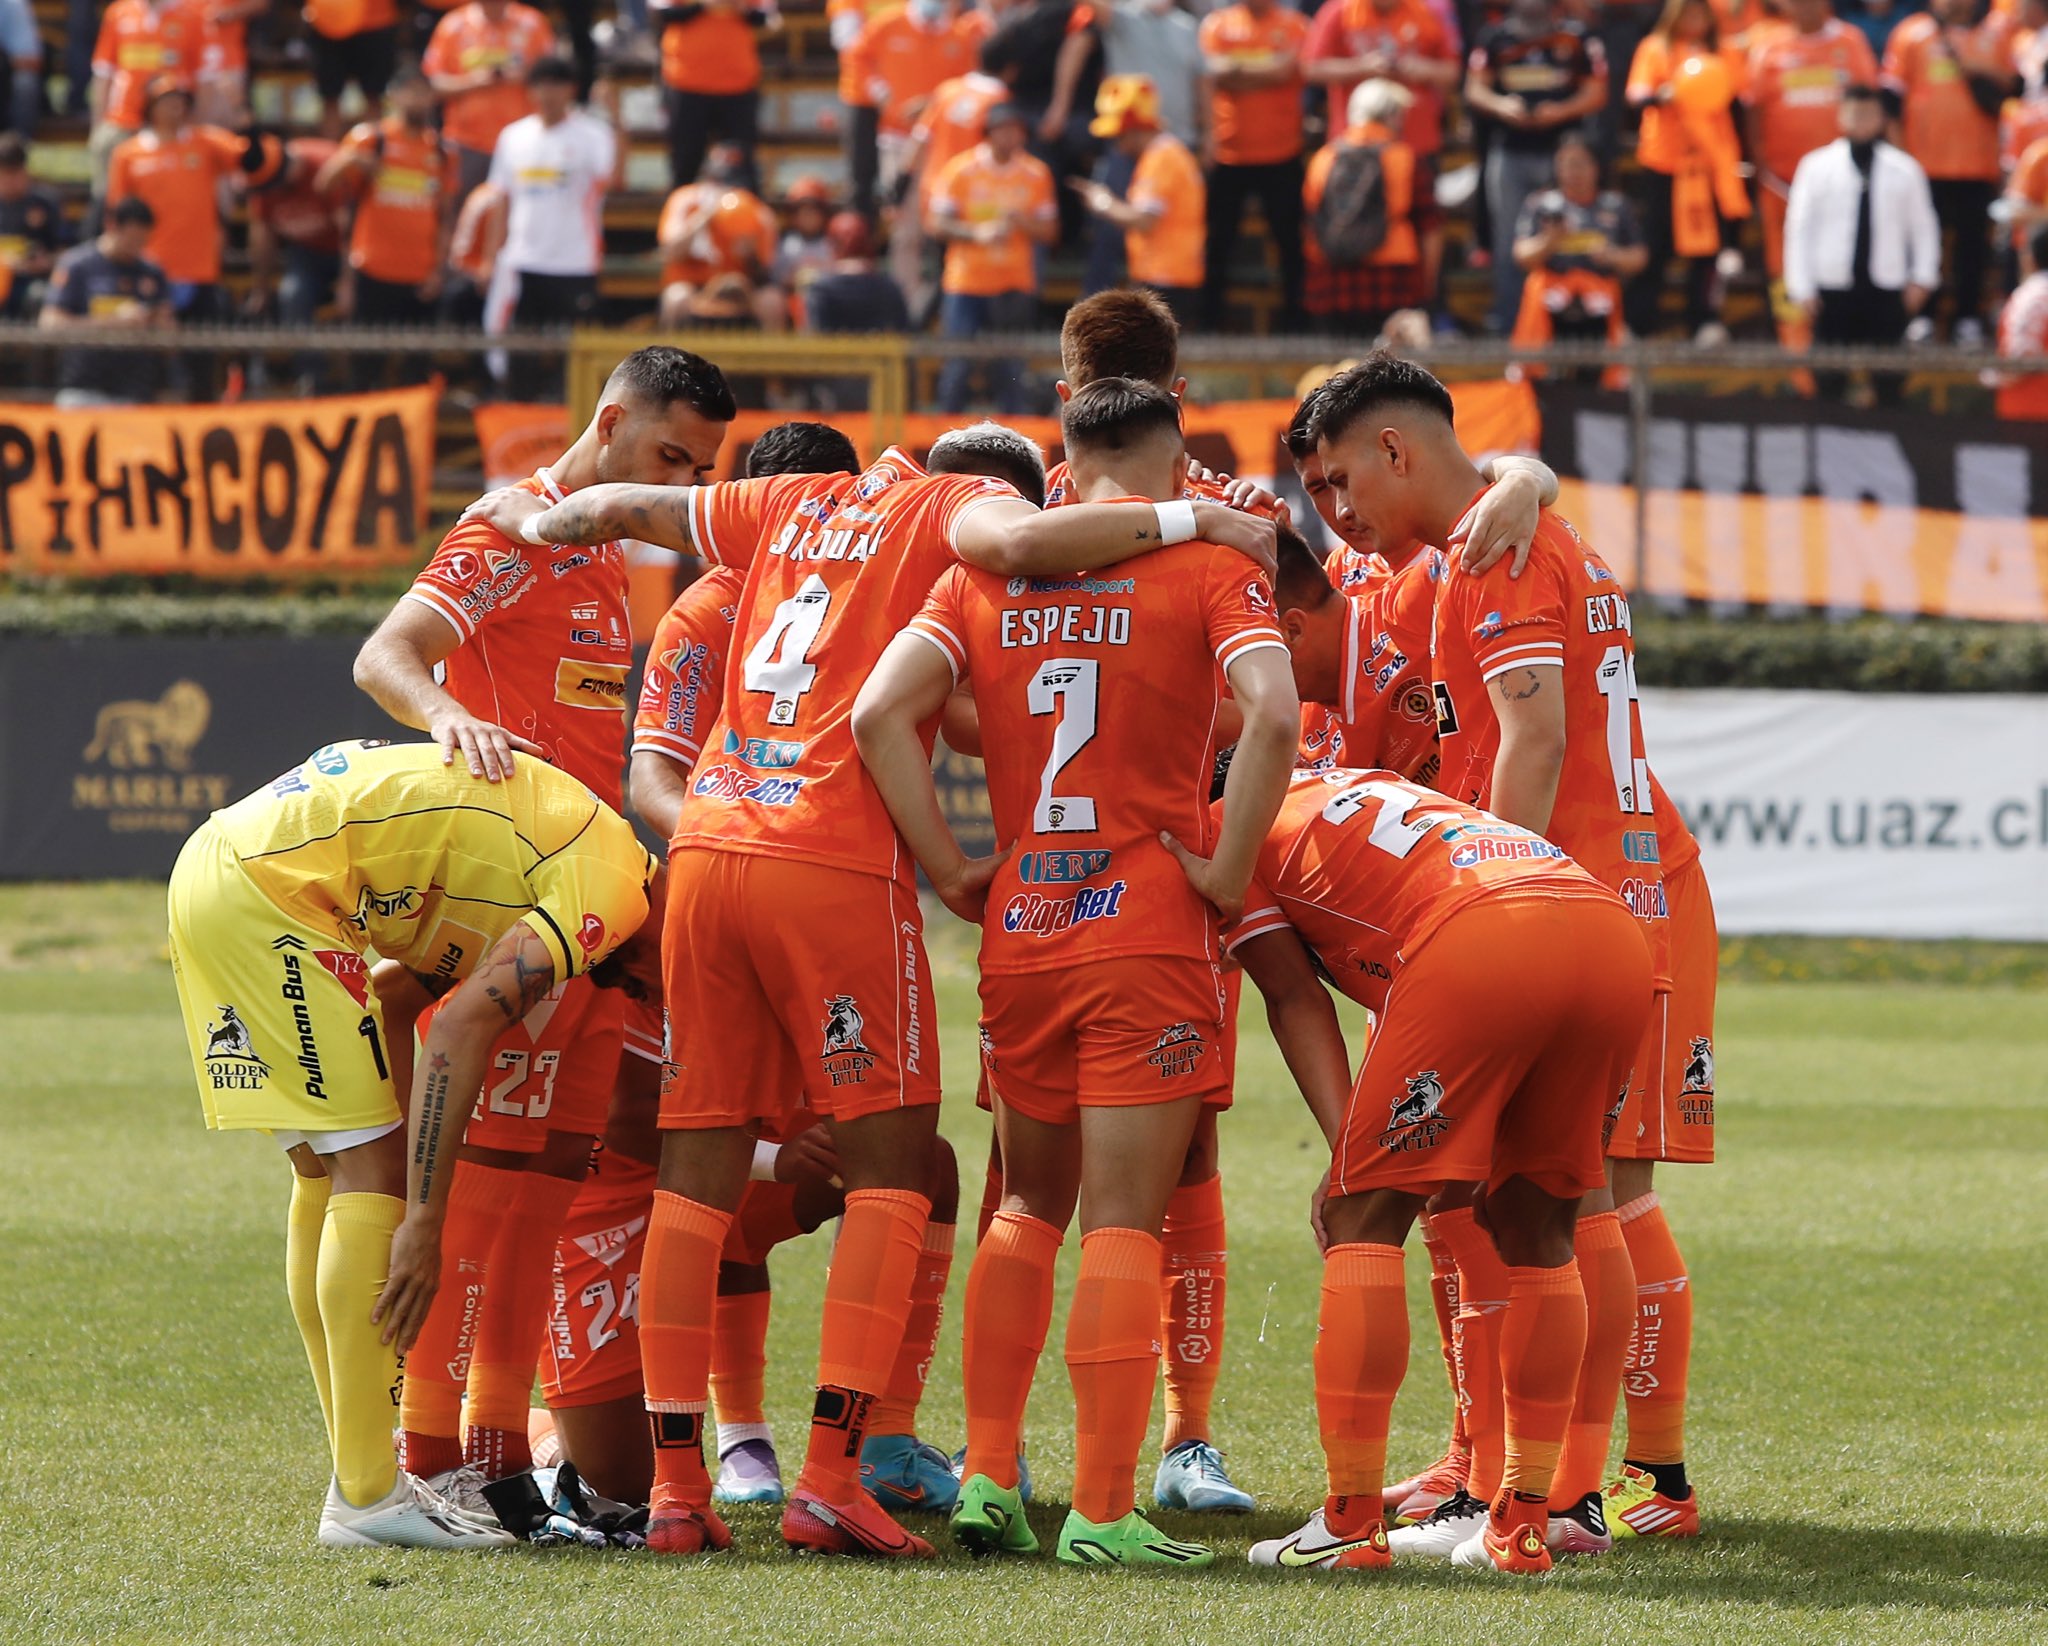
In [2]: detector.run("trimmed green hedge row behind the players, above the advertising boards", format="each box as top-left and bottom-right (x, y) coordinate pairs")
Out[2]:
(0, 588), (2048, 692)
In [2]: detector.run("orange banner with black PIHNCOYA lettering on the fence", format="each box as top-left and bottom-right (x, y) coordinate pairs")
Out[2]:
(0, 385), (440, 577)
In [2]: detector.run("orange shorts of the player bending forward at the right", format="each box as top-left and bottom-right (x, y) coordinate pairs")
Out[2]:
(1331, 893), (1651, 1198)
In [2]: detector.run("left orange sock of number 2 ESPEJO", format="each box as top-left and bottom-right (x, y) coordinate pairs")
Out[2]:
(961, 1212), (1063, 1486)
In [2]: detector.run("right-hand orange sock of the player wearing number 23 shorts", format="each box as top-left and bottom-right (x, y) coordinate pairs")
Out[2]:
(463, 1171), (582, 1480)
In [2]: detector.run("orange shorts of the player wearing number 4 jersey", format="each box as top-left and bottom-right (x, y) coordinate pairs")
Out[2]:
(662, 848), (938, 1130)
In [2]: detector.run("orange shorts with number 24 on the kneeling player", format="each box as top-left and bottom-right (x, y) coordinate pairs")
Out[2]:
(541, 1149), (655, 1409)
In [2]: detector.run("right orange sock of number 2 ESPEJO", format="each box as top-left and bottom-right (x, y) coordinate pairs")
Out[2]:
(1067, 1228), (1159, 1525)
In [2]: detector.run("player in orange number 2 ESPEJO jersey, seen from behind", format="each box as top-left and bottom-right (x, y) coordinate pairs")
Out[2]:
(854, 377), (1296, 1570)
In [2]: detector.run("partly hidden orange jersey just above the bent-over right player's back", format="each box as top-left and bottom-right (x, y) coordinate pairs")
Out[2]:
(1307, 549), (1444, 784)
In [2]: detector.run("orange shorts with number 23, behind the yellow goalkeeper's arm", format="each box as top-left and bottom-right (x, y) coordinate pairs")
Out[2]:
(458, 977), (627, 1155)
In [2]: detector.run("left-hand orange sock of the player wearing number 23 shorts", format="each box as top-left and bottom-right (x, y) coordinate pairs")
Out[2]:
(399, 1161), (512, 1478)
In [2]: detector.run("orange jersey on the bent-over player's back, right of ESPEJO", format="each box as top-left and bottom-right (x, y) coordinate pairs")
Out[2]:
(1217, 768), (1612, 1011)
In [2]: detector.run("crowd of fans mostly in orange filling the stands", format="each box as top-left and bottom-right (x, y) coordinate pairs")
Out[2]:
(0, 0), (2048, 409)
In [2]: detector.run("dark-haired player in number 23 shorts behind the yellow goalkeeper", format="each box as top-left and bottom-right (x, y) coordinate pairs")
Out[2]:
(356, 346), (737, 1525)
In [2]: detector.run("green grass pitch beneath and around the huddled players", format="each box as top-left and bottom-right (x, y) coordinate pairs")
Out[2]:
(0, 886), (2048, 1646)
